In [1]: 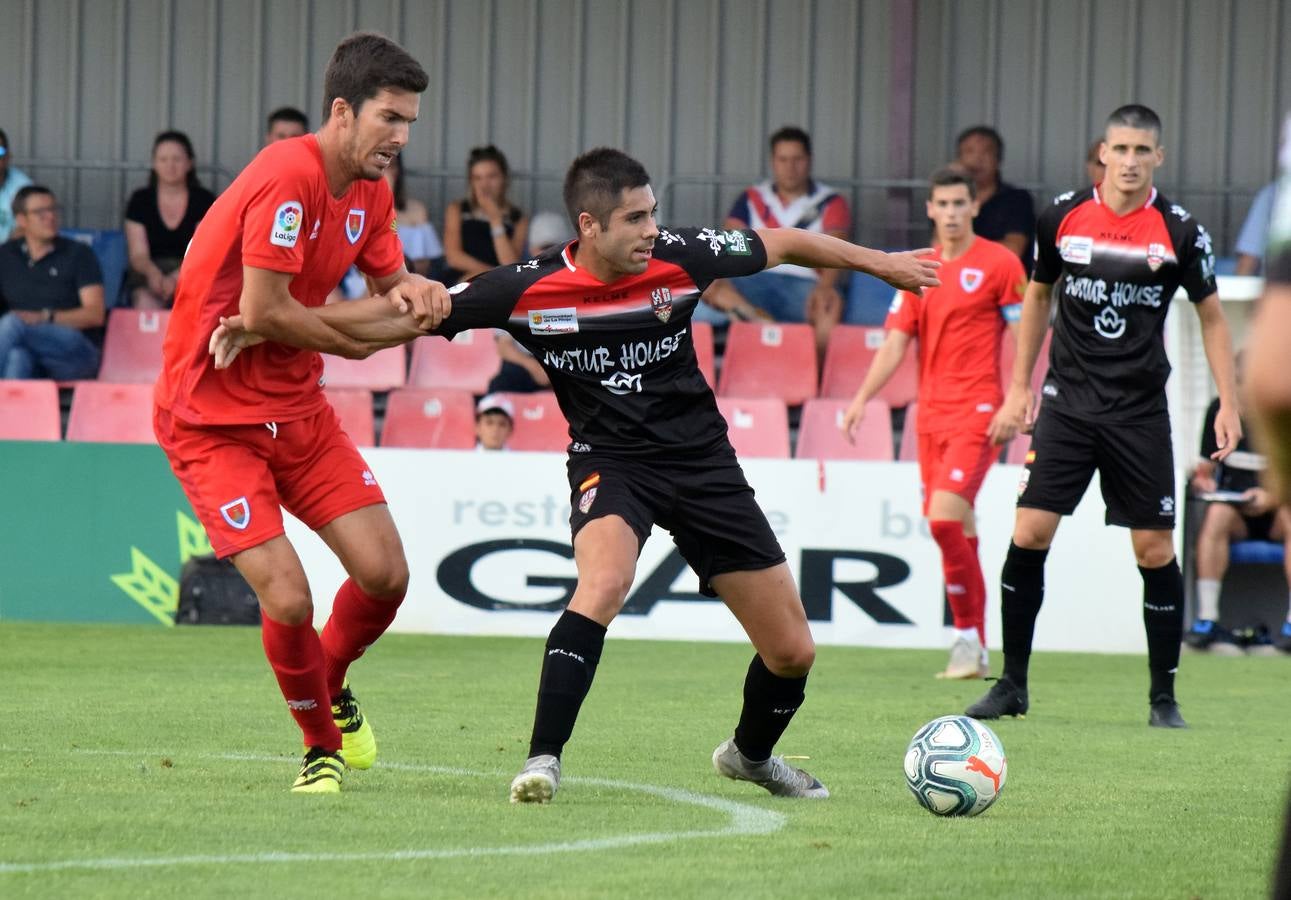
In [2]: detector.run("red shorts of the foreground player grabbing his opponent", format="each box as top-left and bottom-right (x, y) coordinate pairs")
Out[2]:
(152, 407), (386, 558)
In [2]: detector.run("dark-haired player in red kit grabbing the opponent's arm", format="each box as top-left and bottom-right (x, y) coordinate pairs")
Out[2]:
(154, 34), (448, 793)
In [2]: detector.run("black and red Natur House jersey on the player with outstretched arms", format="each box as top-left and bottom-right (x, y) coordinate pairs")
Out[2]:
(435, 222), (767, 456)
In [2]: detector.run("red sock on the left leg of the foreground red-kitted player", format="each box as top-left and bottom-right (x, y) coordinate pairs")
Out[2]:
(259, 615), (341, 750)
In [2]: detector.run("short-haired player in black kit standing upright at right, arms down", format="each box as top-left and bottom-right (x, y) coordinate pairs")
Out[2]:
(967, 105), (1242, 728)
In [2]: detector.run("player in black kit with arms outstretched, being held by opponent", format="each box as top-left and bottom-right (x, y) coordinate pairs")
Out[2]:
(212, 148), (939, 802)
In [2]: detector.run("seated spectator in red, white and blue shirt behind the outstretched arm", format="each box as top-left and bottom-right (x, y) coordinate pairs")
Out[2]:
(696, 125), (852, 356)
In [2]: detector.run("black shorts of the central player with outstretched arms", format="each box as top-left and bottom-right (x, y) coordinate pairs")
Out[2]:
(567, 448), (785, 597)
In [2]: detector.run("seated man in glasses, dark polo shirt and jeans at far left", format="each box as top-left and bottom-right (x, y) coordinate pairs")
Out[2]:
(0, 185), (103, 381)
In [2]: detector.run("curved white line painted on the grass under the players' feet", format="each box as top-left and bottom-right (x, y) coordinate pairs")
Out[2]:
(0, 746), (788, 875)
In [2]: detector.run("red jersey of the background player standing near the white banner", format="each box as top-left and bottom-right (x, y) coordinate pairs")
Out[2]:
(886, 238), (1026, 434)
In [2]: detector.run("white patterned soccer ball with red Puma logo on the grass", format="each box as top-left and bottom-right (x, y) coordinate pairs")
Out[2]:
(905, 715), (1008, 816)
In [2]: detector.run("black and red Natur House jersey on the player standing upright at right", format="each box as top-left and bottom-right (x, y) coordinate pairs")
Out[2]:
(1033, 187), (1215, 421)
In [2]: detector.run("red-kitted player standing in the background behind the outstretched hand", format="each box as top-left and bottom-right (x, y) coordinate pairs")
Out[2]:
(840, 169), (1026, 678)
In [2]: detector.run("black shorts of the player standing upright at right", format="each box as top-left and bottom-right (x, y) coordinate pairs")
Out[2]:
(1017, 405), (1175, 528)
